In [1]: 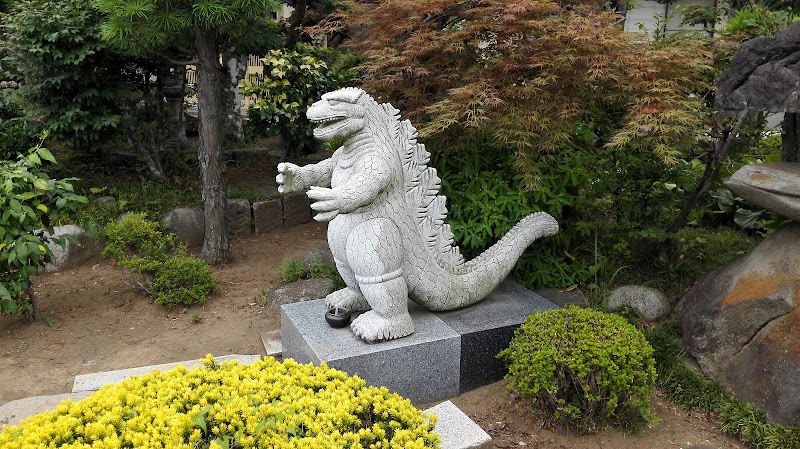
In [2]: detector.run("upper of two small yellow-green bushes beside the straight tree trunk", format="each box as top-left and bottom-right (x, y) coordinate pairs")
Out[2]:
(103, 212), (186, 275)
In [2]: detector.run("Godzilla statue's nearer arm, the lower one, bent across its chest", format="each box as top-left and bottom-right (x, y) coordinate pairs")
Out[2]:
(308, 156), (392, 221)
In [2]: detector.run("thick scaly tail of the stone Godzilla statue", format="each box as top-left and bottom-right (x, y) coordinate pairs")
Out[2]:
(413, 212), (558, 311)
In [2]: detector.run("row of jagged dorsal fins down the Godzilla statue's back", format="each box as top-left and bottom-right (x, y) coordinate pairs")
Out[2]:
(398, 117), (464, 267)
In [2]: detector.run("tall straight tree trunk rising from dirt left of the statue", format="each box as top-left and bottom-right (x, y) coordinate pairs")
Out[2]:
(194, 23), (230, 265)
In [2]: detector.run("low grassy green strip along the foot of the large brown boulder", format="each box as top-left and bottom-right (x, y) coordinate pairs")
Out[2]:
(645, 323), (800, 449)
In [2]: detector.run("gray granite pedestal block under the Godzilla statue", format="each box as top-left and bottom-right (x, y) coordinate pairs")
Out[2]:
(281, 281), (556, 405)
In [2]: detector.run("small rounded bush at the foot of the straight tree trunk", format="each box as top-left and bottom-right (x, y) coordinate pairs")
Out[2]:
(150, 256), (216, 309)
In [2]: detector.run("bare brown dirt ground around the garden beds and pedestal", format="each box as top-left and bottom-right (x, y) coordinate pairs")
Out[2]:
(0, 155), (745, 449)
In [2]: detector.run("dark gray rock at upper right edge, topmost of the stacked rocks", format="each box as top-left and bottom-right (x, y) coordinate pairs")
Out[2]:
(714, 23), (800, 112)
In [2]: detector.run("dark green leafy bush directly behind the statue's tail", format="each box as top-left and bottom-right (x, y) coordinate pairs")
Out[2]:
(431, 117), (692, 288)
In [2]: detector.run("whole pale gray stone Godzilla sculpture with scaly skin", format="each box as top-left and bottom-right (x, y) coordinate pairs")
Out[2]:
(277, 88), (558, 342)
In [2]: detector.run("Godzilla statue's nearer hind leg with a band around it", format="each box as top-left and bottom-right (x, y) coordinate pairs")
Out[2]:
(347, 218), (414, 342)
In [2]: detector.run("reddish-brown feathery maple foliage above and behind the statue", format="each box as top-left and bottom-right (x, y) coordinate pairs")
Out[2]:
(318, 0), (712, 186)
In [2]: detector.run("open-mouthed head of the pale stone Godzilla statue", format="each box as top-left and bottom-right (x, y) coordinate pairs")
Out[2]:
(306, 87), (367, 140)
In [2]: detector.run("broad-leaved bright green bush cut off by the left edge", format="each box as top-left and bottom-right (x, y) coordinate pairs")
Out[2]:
(0, 142), (87, 314)
